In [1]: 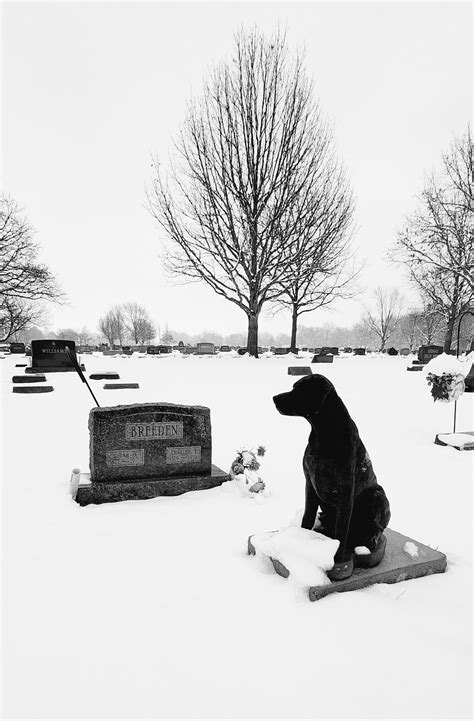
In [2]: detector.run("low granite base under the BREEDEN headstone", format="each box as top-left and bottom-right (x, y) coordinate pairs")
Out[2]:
(75, 465), (230, 506)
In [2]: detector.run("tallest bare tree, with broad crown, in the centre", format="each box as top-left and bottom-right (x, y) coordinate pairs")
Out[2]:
(148, 31), (356, 356)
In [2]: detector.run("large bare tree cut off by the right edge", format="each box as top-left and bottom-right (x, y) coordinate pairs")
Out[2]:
(392, 129), (474, 352)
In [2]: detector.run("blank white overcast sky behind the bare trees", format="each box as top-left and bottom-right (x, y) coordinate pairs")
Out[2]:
(1, 2), (472, 333)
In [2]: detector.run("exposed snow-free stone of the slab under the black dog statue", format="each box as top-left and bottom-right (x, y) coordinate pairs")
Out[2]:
(248, 528), (447, 601)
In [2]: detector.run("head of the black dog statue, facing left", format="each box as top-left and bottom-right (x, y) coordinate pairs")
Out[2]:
(273, 373), (334, 419)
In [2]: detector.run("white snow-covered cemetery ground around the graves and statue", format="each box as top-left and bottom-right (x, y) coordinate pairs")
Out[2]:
(0, 354), (474, 719)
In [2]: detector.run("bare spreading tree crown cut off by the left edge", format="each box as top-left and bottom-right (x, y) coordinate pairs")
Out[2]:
(0, 195), (62, 301)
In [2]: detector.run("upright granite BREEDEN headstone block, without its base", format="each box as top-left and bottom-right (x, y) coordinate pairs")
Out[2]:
(89, 403), (212, 481)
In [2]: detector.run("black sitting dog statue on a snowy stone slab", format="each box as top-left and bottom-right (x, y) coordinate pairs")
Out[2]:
(273, 373), (390, 581)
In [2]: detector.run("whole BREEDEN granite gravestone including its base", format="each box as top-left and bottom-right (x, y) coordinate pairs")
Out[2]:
(76, 403), (229, 505)
